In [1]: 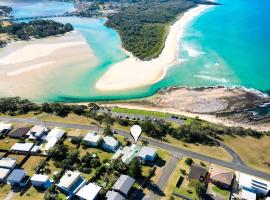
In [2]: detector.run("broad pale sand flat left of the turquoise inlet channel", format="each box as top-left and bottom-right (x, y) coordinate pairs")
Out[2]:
(0, 31), (98, 98)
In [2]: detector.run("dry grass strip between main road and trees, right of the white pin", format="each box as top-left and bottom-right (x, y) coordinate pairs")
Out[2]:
(166, 135), (232, 161)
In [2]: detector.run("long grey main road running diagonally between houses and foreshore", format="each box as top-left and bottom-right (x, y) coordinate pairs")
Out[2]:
(0, 117), (270, 180)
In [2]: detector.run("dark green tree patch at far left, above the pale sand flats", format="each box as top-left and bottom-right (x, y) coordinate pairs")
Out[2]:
(0, 20), (73, 40)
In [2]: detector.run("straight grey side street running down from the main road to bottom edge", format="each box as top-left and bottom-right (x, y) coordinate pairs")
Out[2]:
(144, 154), (181, 200)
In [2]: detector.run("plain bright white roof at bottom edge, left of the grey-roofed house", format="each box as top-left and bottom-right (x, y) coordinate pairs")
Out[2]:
(76, 183), (101, 200)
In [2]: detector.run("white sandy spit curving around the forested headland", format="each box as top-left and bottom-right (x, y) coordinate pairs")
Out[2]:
(96, 5), (211, 90)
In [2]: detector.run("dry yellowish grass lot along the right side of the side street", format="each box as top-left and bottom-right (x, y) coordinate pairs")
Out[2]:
(161, 157), (210, 200)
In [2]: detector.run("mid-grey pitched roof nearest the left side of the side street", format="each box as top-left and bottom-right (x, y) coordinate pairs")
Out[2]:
(112, 175), (135, 195)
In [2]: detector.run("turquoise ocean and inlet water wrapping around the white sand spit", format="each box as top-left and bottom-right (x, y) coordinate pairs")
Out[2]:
(0, 0), (270, 101)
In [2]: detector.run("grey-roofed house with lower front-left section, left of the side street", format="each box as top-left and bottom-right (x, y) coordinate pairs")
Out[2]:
(106, 175), (135, 200)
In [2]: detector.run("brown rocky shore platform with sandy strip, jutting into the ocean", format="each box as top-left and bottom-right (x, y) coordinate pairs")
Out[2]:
(99, 86), (270, 131)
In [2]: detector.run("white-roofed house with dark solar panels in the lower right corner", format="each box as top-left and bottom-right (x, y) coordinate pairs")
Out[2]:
(239, 172), (270, 195)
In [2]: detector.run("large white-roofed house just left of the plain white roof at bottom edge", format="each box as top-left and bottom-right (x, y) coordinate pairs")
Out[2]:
(56, 170), (86, 195)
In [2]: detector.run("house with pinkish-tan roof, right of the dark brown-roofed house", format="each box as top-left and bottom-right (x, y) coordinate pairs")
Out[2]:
(209, 165), (234, 189)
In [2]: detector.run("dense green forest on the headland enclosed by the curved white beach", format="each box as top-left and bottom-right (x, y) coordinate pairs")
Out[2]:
(106, 0), (196, 60)
